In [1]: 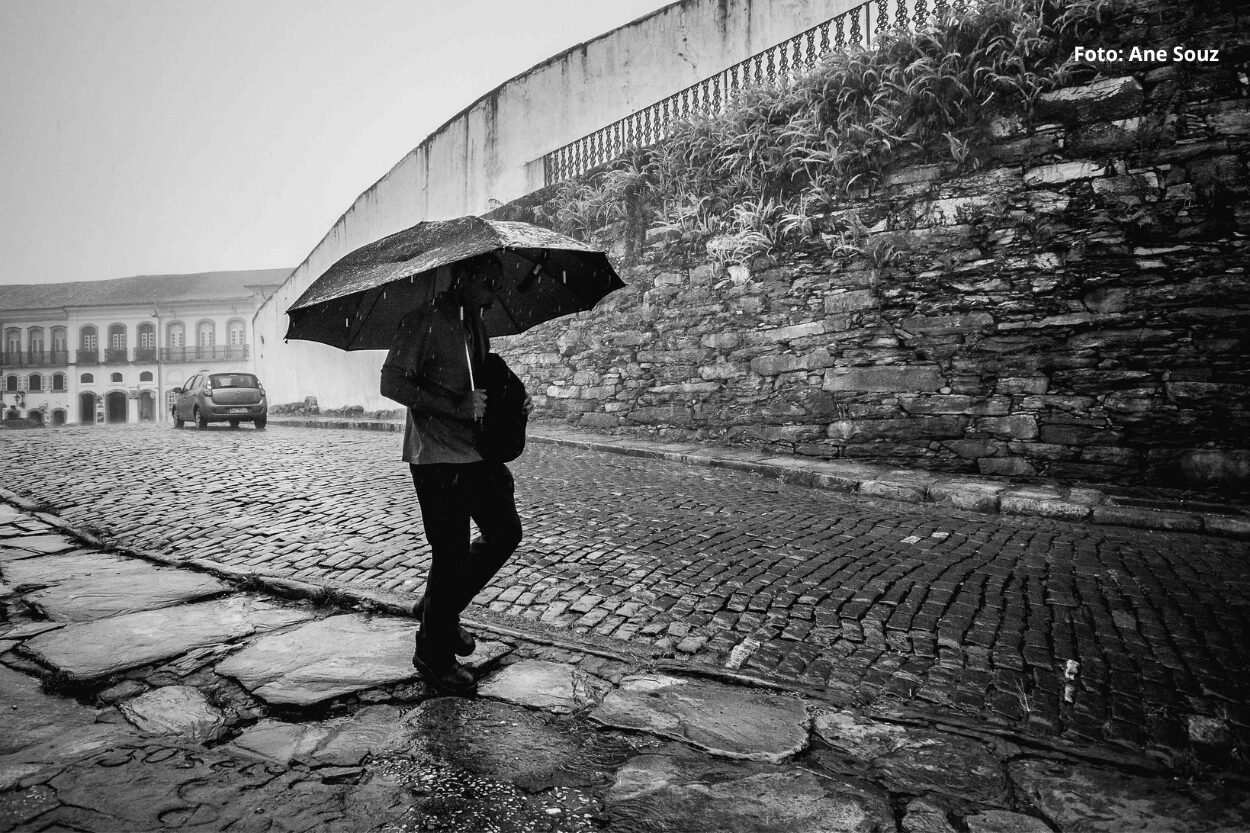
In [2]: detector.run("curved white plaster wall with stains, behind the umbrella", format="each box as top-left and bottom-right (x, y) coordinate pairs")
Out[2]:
(253, 0), (858, 410)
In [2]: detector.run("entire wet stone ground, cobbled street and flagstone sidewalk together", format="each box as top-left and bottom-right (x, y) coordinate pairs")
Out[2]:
(0, 427), (1250, 833)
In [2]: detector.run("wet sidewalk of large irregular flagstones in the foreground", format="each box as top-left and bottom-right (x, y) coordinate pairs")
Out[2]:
(0, 495), (1250, 833)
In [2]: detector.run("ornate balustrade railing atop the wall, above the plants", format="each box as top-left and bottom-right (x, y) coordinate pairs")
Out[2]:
(543, 0), (955, 185)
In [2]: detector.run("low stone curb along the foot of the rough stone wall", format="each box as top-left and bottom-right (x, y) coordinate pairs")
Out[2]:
(269, 418), (1250, 540)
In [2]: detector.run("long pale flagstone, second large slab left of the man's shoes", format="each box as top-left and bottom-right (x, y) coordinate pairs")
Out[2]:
(23, 597), (311, 683)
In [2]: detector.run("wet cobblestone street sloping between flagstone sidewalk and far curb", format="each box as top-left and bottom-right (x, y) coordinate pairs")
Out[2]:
(0, 427), (1250, 753)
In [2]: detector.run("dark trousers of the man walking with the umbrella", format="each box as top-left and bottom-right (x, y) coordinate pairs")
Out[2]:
(411, 462), (521, 663)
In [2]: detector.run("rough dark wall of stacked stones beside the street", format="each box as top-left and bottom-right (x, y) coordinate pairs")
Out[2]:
(496, 46), (1250, 488)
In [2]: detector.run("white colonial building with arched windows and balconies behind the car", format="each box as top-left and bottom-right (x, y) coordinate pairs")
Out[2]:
(0, 269), (290, 425)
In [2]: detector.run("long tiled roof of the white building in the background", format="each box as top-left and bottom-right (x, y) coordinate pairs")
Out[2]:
(0, 269), (291, 311)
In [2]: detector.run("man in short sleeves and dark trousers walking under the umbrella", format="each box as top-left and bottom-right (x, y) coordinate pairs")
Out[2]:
(381, 261), (522, 693)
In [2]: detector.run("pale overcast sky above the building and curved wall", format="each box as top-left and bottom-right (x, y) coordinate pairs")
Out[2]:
(0, 0), (671, 285)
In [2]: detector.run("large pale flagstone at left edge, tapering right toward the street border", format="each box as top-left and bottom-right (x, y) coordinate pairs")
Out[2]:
(0, 550), (231, 622)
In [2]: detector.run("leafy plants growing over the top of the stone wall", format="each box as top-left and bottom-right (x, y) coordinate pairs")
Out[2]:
(507, 0), (1138, 265)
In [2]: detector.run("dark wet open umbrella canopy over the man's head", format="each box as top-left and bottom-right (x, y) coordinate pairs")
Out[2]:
(286, 216), (625, 350)
